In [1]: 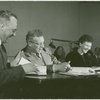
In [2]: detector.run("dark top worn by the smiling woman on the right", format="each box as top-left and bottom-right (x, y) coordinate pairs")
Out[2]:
(66, 49), (96, 67)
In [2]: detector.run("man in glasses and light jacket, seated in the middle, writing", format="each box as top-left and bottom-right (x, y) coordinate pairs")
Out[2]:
(11, 30), (70, 74)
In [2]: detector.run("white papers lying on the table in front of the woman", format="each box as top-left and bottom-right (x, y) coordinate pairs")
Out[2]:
(59, 67), (95, 76)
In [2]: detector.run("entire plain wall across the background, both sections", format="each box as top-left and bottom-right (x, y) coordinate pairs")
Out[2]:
(0, 1), (100, 59)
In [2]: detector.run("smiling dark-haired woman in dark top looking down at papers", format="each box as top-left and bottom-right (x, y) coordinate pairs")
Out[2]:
(66, 34), (95, 67)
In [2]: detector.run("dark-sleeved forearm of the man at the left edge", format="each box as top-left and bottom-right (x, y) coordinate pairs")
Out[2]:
(0, 66), (25, 86)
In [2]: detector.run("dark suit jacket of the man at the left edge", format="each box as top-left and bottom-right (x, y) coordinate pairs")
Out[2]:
(0, 45), (25, 98)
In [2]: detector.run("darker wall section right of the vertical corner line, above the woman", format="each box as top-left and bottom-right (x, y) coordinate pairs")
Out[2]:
(79, 2), (100, 48)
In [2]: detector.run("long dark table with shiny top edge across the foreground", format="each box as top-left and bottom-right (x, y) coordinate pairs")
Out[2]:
(21, 73), (100, 99)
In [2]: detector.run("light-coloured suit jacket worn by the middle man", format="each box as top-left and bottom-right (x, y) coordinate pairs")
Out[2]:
(13, 46), (53, 72)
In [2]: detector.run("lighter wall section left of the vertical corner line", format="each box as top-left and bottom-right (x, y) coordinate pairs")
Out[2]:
(0, 1), (79, 56)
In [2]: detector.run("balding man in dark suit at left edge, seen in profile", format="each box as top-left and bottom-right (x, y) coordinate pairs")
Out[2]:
(0, 10), (37, 99)
